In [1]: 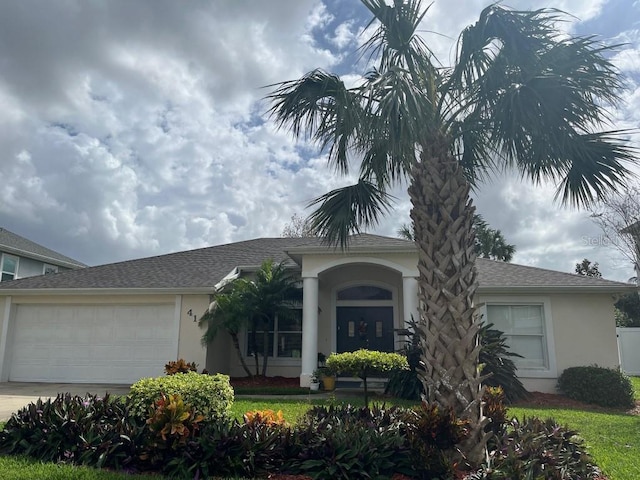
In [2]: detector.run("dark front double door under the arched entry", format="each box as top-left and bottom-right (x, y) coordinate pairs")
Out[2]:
(336, 307), (393, 353)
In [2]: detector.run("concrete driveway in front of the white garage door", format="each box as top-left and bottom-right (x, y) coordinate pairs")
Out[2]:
(0, 382), (130, 421)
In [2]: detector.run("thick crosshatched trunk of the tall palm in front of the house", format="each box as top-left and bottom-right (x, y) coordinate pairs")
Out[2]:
(409, 136), (486, 464)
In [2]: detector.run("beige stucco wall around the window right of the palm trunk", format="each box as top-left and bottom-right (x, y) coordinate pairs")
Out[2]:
(476, 293), (618, 393)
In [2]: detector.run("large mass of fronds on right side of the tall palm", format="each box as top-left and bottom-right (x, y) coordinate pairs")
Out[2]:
(446, 5), (635, 205)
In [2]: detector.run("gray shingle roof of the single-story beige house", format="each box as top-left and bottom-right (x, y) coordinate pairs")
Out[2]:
(0, 234), (633, 293)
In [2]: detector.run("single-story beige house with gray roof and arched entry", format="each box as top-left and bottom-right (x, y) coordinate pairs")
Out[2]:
(0, 234), (634, 392)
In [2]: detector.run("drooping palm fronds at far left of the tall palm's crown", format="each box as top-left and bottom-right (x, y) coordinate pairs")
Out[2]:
(267, 70), (362, 173)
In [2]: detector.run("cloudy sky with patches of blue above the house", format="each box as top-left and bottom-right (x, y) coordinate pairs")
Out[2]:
(0, 0), (640, 281)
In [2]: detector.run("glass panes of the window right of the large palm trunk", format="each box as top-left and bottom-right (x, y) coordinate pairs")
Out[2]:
(487, 304), (550, 370)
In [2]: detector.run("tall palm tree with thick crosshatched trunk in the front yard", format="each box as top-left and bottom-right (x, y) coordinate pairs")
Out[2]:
(268, 0), (634, 461)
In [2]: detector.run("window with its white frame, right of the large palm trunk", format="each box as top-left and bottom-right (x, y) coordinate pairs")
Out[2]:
(483, 297), (557, 377)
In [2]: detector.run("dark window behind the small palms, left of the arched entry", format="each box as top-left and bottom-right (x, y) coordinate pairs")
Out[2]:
(247, 309), (302, 358)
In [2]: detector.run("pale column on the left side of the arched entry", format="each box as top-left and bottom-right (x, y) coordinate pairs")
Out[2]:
(300, 277), (318, 387)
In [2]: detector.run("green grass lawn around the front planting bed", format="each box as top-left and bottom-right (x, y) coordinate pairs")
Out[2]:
(0, 378), (640, 480)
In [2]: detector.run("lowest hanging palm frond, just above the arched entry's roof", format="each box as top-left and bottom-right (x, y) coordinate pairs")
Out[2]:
(308, 179), (393, 249)
